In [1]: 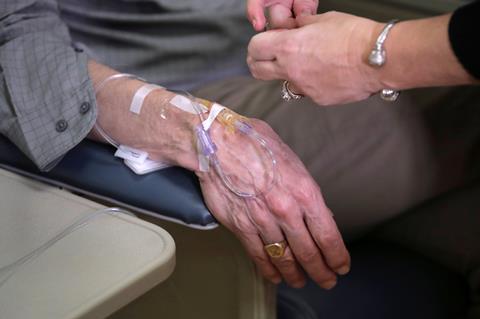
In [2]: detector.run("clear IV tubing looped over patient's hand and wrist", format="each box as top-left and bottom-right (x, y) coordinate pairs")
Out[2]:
(95, 73), (277, 198)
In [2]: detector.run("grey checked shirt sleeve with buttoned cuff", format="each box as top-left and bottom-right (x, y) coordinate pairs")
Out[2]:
(0, 0), (97, 170)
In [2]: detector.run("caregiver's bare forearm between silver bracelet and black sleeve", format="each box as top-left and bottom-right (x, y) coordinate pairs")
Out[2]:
(364, 14), (478, 89)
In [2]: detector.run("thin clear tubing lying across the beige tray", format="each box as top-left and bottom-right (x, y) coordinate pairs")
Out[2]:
(0, 207), (135, 288)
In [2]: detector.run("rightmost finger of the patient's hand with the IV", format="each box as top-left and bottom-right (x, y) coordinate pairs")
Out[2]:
(305, 195), (350, 275)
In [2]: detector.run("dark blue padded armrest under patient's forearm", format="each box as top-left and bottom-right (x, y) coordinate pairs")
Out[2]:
(0, 136), (217, 229)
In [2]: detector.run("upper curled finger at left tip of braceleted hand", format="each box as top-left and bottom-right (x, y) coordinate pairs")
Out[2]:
(248, 30), (284, 61)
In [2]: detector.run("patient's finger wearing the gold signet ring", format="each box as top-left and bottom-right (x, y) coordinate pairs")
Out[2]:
(246, 200), (305, 288)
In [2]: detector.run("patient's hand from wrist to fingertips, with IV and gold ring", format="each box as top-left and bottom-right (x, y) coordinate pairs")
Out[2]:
(197, 120), (350, 288)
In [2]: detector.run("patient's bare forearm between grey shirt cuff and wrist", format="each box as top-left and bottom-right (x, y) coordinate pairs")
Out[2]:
(88, 61), (199, 170)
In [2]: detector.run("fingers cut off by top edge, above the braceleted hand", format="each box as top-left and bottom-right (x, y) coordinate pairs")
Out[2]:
(247, 0), (318, 31)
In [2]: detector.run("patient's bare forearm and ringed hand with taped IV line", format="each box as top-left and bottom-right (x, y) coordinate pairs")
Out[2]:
(89, 61), (350, 288)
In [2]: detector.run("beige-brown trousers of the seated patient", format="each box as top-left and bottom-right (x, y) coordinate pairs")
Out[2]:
(195, 77), (480, 318)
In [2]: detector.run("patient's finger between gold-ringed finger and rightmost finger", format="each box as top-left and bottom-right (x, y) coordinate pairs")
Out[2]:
(283, 218), (337, 289)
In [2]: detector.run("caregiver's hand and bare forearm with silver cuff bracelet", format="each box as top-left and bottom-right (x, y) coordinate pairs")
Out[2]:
(247, 12), (479, 105)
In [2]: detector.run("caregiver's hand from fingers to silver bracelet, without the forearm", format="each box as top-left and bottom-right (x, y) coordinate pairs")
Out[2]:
(247, 12), (383, 105)
